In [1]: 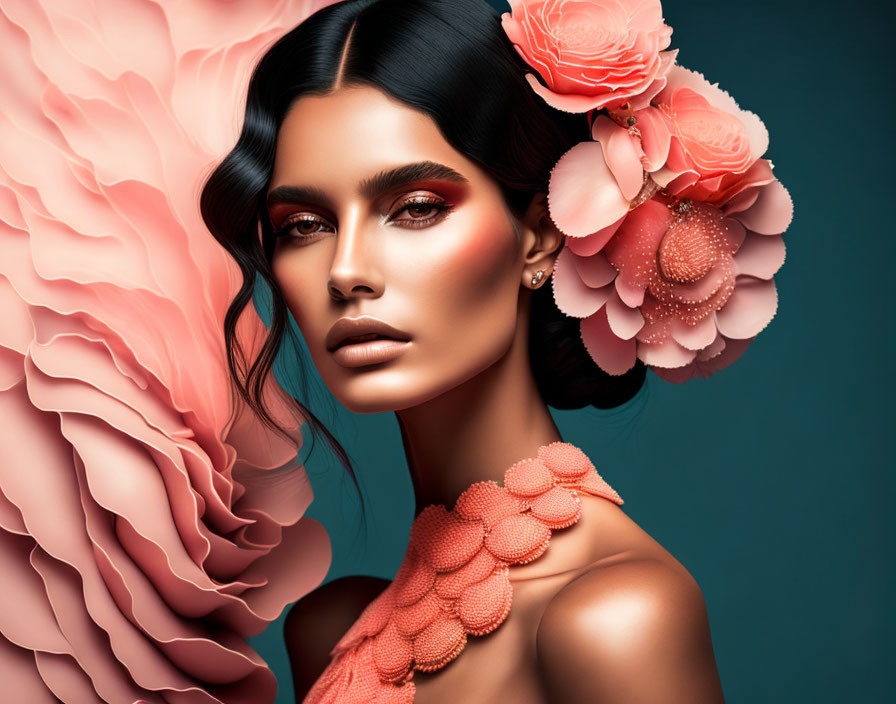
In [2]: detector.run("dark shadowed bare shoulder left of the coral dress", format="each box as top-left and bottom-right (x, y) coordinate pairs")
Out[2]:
(283, 576), (389, 701)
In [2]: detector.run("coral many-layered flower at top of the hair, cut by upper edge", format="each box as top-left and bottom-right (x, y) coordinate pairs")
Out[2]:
(501, 0), (676, 112)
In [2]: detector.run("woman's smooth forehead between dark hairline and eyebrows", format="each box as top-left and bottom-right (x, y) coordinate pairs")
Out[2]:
(272, 86), (480, 186)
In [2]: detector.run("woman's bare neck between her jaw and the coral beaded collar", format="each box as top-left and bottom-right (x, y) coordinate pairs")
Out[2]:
(396, 306), (562, 515)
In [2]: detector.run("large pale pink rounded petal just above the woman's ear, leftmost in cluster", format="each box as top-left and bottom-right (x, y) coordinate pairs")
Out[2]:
(548, 142), (629, 237)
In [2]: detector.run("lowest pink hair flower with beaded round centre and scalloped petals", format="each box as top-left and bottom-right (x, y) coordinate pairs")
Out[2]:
(553, 190), (792, 382)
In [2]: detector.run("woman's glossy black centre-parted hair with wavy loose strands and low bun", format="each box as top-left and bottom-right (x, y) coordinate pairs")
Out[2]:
(200, 0), (646, 479)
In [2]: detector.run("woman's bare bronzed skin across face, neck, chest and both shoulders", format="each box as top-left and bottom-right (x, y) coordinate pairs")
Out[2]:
(269, 85), (722, 704)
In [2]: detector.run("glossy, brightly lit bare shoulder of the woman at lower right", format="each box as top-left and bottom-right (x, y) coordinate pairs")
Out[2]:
(537, 549), (724, 704)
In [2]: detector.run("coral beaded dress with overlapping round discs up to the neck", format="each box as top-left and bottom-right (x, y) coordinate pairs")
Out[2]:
(304, 442), (622, 704)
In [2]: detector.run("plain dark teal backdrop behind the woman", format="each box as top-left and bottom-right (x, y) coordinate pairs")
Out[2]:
(252, 0), (896, 704)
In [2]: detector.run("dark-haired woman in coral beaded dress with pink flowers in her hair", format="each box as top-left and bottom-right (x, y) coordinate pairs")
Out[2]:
(202, 0), (790, 703)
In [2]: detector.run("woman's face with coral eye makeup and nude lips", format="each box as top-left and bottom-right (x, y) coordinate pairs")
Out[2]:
(268, 86), (524, 413)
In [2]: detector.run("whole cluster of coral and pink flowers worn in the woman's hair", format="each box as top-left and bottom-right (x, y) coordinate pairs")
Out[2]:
(501, 0), (793, 383)
